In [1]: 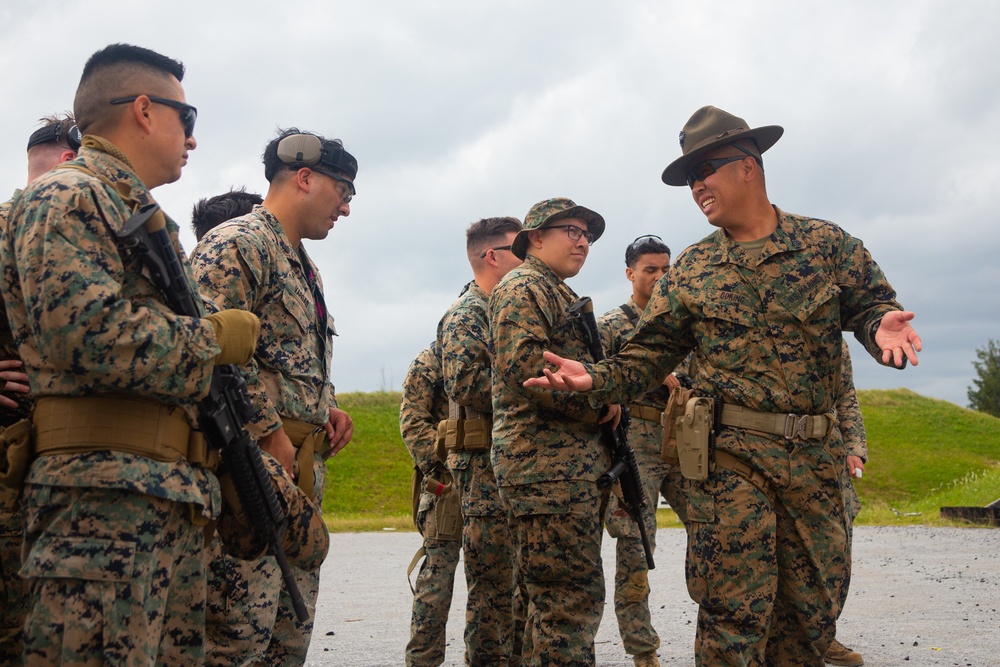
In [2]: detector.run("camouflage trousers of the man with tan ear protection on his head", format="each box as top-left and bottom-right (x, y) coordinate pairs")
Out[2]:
(206, 453), (326, 667)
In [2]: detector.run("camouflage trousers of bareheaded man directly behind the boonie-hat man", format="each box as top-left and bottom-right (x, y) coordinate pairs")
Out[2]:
(449, 451), (524, 667)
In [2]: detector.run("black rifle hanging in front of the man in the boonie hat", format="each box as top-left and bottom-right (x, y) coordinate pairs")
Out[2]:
(569, 296), (656, 570)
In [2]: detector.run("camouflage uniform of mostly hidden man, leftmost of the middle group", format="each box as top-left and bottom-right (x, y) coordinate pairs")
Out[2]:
(399, 347), (462, 667)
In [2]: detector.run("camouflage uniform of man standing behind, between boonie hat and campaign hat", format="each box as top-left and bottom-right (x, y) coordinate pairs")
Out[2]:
(597, 297), (686, 655)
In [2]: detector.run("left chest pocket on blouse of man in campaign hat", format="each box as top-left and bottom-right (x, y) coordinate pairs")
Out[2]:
(697, 290), (759, 374)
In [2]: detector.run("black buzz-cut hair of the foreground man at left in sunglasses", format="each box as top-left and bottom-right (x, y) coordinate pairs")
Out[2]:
(73, 44), (184, 134)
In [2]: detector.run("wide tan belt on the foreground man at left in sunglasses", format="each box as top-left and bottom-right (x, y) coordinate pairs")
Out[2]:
(32, 395), (219, 469)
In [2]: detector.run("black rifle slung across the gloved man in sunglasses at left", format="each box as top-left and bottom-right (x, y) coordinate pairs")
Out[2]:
(118, 204), (309, 623)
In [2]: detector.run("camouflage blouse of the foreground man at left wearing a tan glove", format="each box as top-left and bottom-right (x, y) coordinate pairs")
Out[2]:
(0, 144), (219, 514)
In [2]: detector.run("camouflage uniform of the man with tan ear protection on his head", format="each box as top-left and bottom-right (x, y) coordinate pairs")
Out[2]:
(191, 205), (336, 665)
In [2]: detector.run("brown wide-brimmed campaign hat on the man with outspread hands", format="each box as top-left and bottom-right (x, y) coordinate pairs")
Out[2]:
(663, 107), (785, 185)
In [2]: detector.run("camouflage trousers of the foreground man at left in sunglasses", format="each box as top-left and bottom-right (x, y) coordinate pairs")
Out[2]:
(21, 484), (205, 666)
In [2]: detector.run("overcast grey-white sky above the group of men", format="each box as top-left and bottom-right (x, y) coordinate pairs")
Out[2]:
(0, 0), (1000, 405)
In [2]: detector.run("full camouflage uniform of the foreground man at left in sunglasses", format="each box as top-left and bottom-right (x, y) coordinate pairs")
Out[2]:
(0, 137), (220, 665)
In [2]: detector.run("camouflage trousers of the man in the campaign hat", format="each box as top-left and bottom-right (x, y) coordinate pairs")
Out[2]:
(685, 438), (850, 667)
